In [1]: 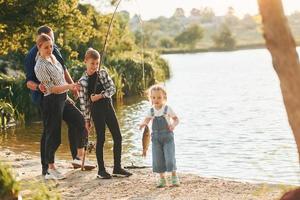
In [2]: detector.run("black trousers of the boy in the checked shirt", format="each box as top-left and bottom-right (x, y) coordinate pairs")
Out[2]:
(91, 98), (122, 171)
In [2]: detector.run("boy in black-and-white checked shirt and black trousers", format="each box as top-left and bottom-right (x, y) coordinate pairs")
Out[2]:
(79, 48), (132, 179)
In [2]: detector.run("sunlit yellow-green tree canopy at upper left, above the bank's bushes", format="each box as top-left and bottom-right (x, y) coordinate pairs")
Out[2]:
(0, 0), (135, 69)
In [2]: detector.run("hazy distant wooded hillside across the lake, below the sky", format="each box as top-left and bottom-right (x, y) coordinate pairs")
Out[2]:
(130, 7), (300, 53)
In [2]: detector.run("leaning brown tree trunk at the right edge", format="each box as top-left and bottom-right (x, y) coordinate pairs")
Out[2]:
(258, 0), (300, 161)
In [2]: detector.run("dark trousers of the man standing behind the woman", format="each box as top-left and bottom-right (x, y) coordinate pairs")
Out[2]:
(40, 95), (85, 174)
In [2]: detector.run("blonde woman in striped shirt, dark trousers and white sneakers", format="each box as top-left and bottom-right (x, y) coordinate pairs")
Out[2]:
(34, 33), (78, 179)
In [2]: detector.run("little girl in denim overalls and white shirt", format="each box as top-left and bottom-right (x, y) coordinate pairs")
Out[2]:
(140, 85), (179, 187)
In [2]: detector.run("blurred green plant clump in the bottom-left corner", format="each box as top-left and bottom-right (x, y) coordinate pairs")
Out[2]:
(0, 162), (20, 199)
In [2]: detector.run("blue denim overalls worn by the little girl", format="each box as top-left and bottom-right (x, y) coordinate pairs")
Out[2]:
(151, 106), (176, 173)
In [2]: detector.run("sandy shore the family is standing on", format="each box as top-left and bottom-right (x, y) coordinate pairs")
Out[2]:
(0, 148), (286, 200)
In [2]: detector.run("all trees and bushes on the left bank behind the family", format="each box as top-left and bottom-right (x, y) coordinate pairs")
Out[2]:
(0, 0), (171, 121)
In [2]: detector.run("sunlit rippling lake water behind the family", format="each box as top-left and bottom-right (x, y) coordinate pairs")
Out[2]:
(0, 50), (300, 184)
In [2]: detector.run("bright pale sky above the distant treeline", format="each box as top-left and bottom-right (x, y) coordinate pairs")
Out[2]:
(82, 0), (300, 20)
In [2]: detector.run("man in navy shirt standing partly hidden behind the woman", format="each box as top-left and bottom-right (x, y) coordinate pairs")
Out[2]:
(25, 26), (96, 175)
